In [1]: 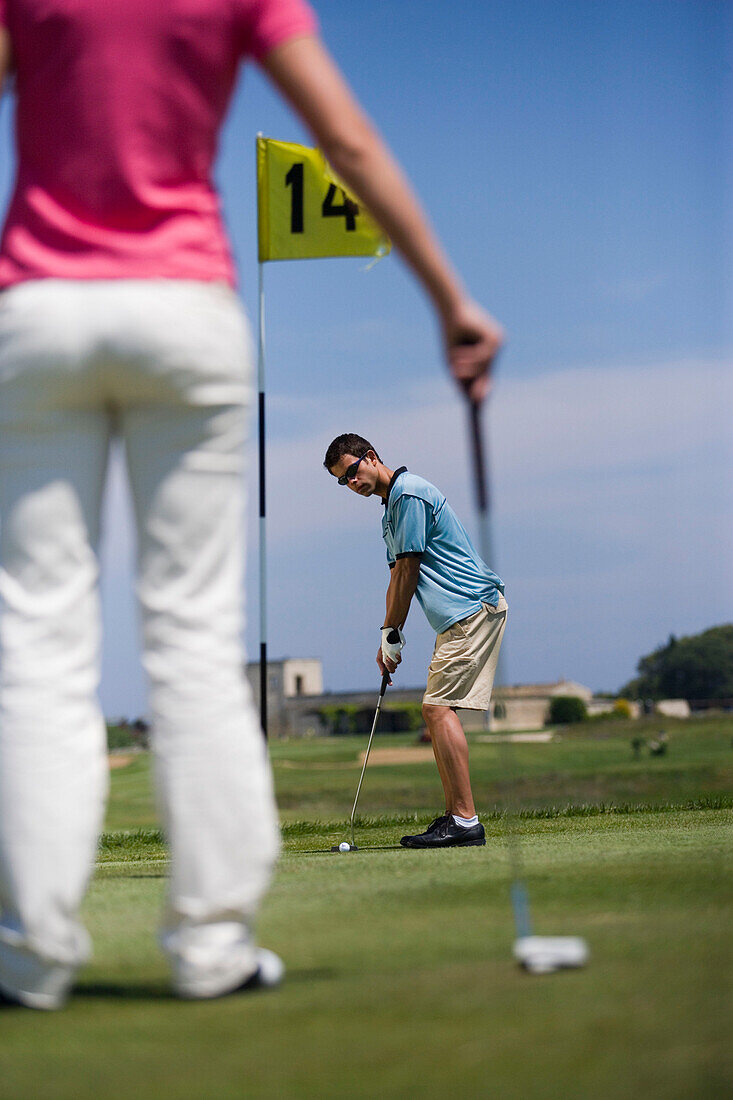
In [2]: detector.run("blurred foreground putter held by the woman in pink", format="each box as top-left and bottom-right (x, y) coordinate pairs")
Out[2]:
(469, 399), (589, 974)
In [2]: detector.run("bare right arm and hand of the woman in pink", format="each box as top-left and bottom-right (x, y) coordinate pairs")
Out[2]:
(262, 36), (503, 402)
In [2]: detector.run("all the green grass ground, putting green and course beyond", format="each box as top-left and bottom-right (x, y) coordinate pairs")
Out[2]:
(0, 721), (733, 1100)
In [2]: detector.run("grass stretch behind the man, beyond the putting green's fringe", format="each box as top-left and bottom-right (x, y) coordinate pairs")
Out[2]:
(102, 719), (733, 829)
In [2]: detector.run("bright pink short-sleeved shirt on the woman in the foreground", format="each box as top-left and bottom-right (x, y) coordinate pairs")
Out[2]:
(0, 0), (316, 288)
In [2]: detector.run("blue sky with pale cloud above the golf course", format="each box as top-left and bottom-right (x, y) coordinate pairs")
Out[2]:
(0, 0), (733, 715)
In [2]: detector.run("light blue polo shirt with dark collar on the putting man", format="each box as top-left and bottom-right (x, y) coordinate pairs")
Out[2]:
(382, 466), (504, 634)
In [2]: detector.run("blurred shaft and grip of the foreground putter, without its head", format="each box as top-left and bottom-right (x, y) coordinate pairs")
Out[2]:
(469, 402), (532, 937)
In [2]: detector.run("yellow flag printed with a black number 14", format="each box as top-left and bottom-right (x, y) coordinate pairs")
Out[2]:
(258, 138), (392, 263)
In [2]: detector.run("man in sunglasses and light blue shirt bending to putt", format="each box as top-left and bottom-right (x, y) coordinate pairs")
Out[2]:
(324, 435), (506, 848)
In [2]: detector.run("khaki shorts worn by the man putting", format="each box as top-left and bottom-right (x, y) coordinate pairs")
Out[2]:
(423, 595), (507, 711)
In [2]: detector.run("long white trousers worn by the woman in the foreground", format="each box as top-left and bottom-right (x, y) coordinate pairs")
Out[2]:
(0, 279), (278, 1008)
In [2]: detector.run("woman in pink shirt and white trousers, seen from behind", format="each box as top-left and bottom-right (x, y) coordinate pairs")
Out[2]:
(0, 0), (501, 1009)
